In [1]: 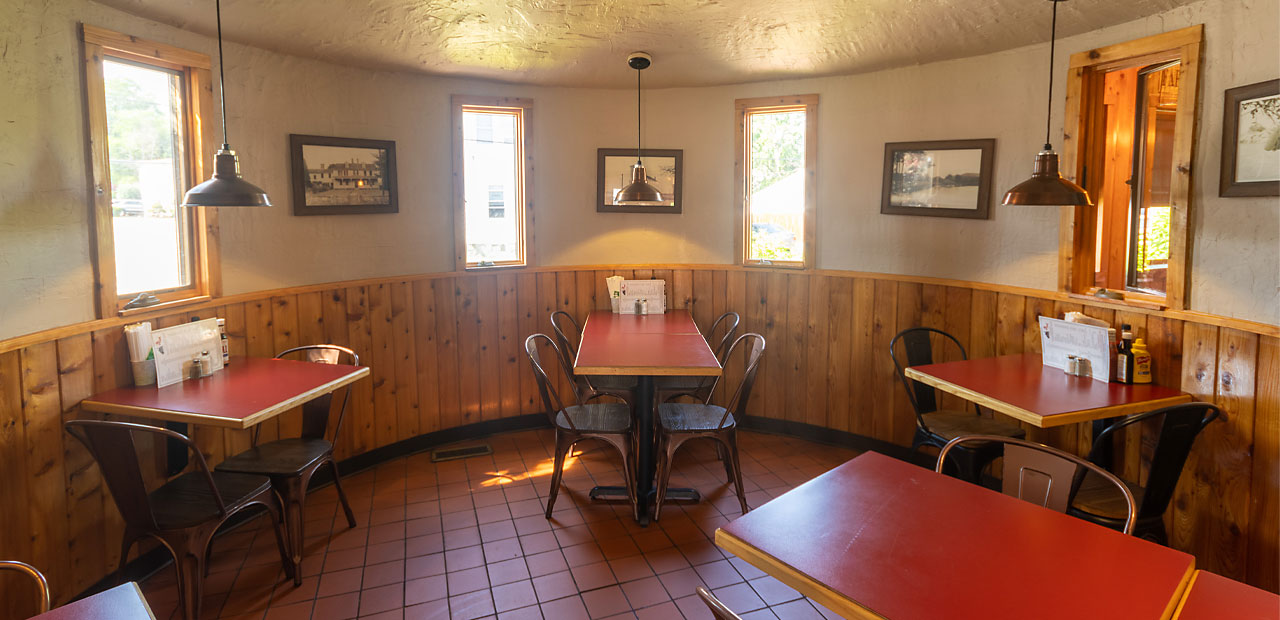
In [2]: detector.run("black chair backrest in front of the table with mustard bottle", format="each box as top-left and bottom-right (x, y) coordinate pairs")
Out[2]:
(1076, 402), (1221, 519)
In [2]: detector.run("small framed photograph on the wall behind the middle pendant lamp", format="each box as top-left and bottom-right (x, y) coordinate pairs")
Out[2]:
(595, 149), (685, 213)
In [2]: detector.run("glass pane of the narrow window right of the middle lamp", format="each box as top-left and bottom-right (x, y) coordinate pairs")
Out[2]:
(746, 110), (805, 261)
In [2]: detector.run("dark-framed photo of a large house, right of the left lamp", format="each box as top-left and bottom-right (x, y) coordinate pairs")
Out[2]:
(289, 133), (399, 215)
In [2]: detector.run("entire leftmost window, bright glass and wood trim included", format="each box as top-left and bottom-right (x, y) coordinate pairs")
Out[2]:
(82, 26), (220, 318)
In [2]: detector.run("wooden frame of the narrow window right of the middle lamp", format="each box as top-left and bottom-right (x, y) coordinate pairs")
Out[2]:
(733, 94), (818, 270)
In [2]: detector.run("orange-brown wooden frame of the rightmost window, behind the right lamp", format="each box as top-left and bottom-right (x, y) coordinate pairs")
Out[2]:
(1057, 24), (1204, 310)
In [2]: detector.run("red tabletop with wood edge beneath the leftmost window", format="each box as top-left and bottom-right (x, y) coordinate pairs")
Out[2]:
(81, 357), (369, 429)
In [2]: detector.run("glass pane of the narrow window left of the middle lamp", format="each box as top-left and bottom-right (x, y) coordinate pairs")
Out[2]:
(462, 110), (524, 264)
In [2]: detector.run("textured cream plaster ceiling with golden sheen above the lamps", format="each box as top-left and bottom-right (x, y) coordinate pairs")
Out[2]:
(97, 0), (1189, 87)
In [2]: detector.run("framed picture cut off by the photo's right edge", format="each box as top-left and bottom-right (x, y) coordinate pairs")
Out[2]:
(1217, 79), (1280, 196)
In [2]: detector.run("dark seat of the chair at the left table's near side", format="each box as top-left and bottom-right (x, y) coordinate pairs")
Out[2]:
(147, 471), (271, 529)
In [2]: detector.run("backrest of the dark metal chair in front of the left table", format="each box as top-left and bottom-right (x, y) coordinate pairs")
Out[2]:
(63, 420), (227, 529)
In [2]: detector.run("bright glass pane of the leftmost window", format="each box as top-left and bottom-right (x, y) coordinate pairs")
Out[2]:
(102, 59), (192, 295)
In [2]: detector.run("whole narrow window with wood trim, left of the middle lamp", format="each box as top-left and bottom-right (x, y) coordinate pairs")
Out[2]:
(453, 95), (532, 270)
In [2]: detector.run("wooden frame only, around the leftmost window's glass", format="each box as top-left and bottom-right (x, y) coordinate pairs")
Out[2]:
(81, 24), (221, 319)
